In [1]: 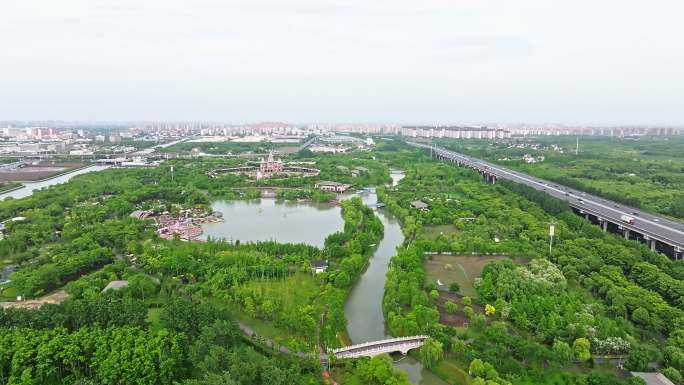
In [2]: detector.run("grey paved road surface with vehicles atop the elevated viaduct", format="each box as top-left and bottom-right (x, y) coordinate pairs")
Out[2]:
(408, 142), (684, 251)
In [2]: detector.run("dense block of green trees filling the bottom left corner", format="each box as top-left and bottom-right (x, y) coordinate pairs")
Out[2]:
(0, 326), (187, 385)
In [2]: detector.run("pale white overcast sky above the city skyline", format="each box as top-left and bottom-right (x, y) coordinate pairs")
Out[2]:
(0, 0), (684, 124)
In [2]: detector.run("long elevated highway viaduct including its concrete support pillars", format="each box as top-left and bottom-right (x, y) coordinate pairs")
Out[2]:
(407, 142), (684, 260)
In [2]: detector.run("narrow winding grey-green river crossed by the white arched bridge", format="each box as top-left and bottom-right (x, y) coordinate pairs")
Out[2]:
(344, 170), (447, 385)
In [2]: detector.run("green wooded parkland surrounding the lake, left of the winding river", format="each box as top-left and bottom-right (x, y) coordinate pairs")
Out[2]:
(0, 149), (391, 384)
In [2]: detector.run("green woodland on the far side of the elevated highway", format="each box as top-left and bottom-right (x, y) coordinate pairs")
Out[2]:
(432, 136), (684, 219)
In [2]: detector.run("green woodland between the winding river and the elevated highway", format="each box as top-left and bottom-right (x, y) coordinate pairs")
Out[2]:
(379, 141), (684, 384)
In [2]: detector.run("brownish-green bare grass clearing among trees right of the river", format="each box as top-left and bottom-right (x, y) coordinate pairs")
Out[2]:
(425, 255), (507, 297)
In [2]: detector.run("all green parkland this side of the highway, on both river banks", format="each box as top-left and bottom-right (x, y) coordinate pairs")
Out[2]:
(0, 140), (684, 385)
